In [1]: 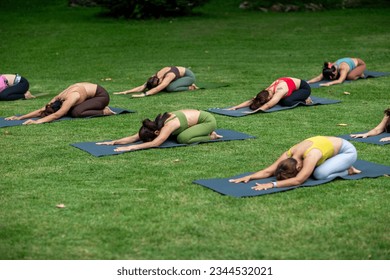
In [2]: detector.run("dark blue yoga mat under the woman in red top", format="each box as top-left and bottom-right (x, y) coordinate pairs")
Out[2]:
(207, 96), (341, 117)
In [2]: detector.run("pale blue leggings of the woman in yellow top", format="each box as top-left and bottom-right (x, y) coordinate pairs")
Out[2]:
(313, 139), (357, 180)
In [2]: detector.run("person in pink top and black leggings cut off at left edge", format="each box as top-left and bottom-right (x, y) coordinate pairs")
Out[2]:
(0, 74), (34, 101)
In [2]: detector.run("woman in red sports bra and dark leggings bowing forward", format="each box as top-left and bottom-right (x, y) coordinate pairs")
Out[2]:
(228, 77), (312, 112)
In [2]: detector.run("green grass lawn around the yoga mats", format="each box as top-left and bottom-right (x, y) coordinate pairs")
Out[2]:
(0, 0), (390, 260)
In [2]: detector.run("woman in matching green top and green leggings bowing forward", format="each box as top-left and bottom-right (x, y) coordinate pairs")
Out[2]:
(97, 109), (222, 152)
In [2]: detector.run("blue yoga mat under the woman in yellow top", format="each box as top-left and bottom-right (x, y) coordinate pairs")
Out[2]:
(193, 160), (390, 197)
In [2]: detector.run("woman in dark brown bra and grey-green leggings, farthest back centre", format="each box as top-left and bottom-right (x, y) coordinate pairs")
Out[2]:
(114, 66), (198, 97)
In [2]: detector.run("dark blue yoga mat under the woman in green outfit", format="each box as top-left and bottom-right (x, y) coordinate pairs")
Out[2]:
(70, 129), (255, 157)
